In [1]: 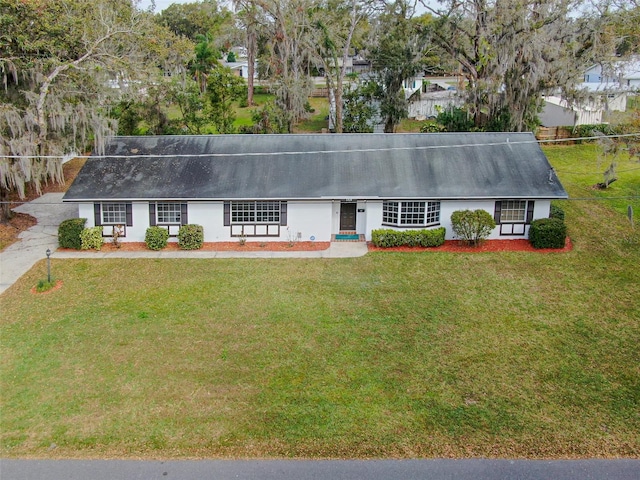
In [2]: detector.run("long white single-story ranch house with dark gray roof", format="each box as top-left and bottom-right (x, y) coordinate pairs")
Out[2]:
(63, 133), (567, 242)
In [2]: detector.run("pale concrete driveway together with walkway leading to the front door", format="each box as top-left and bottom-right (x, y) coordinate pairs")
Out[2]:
(0, 193), (368, 294)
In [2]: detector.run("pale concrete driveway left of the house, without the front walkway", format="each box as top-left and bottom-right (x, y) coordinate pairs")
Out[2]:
(0, 193), (78, 293)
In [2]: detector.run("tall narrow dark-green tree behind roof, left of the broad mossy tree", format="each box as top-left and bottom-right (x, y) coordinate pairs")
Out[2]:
(370, 0), (426, 133)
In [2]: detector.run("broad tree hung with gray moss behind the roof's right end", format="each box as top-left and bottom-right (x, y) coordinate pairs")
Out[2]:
(421, 0), (604, 131)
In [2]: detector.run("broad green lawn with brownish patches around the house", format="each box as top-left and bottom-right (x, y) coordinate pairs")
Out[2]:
(0, 147), (640, 458)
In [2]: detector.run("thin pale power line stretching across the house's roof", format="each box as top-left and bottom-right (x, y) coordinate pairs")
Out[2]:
(0, 132), (640, 160)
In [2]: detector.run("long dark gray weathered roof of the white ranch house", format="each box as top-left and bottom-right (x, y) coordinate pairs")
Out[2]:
(64, 133), (567, 201)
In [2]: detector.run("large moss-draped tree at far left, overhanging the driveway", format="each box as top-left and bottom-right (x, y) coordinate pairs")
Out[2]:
(0, 0), (188, 222)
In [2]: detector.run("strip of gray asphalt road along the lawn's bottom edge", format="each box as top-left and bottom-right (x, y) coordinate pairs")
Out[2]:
(0, 459), (640, 480)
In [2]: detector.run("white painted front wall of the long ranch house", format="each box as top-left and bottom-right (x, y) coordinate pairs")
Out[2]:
(78, 200), (551, 242)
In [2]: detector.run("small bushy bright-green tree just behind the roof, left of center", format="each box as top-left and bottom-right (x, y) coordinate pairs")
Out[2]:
(207, 64), (247, 133)
